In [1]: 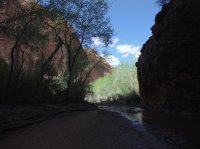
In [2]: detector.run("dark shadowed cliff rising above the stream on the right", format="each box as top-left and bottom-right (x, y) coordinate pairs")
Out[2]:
(136, 0), (200, 112)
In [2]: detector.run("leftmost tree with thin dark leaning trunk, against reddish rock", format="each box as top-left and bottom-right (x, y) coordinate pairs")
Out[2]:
(0, 0), (49, 99)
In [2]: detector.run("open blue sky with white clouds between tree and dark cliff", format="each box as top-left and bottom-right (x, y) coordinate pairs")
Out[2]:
(94, 0), (160, 66)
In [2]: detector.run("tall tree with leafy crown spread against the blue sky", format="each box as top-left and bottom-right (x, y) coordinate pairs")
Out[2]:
(42, 0), (113, 98)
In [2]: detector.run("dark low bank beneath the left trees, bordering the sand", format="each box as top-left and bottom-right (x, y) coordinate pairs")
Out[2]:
(0, 102), (98, 133)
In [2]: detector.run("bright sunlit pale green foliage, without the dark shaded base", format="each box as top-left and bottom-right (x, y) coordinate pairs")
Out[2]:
(89, 63), (139, 102)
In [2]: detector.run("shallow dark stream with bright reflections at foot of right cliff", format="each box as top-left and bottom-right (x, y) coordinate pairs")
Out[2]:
(99, 106), (200, 149)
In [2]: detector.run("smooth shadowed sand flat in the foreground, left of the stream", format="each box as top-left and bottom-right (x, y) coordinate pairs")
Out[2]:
(0, 110), (166, 149)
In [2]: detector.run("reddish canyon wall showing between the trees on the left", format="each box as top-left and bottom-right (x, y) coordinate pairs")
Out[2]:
(0, 0), (112, 82)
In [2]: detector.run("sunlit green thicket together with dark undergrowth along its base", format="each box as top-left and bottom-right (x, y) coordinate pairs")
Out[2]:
(86, 63), (140, 105)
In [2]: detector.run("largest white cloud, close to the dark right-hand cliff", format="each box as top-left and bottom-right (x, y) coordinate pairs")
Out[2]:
(116, 44), (141, 57)
